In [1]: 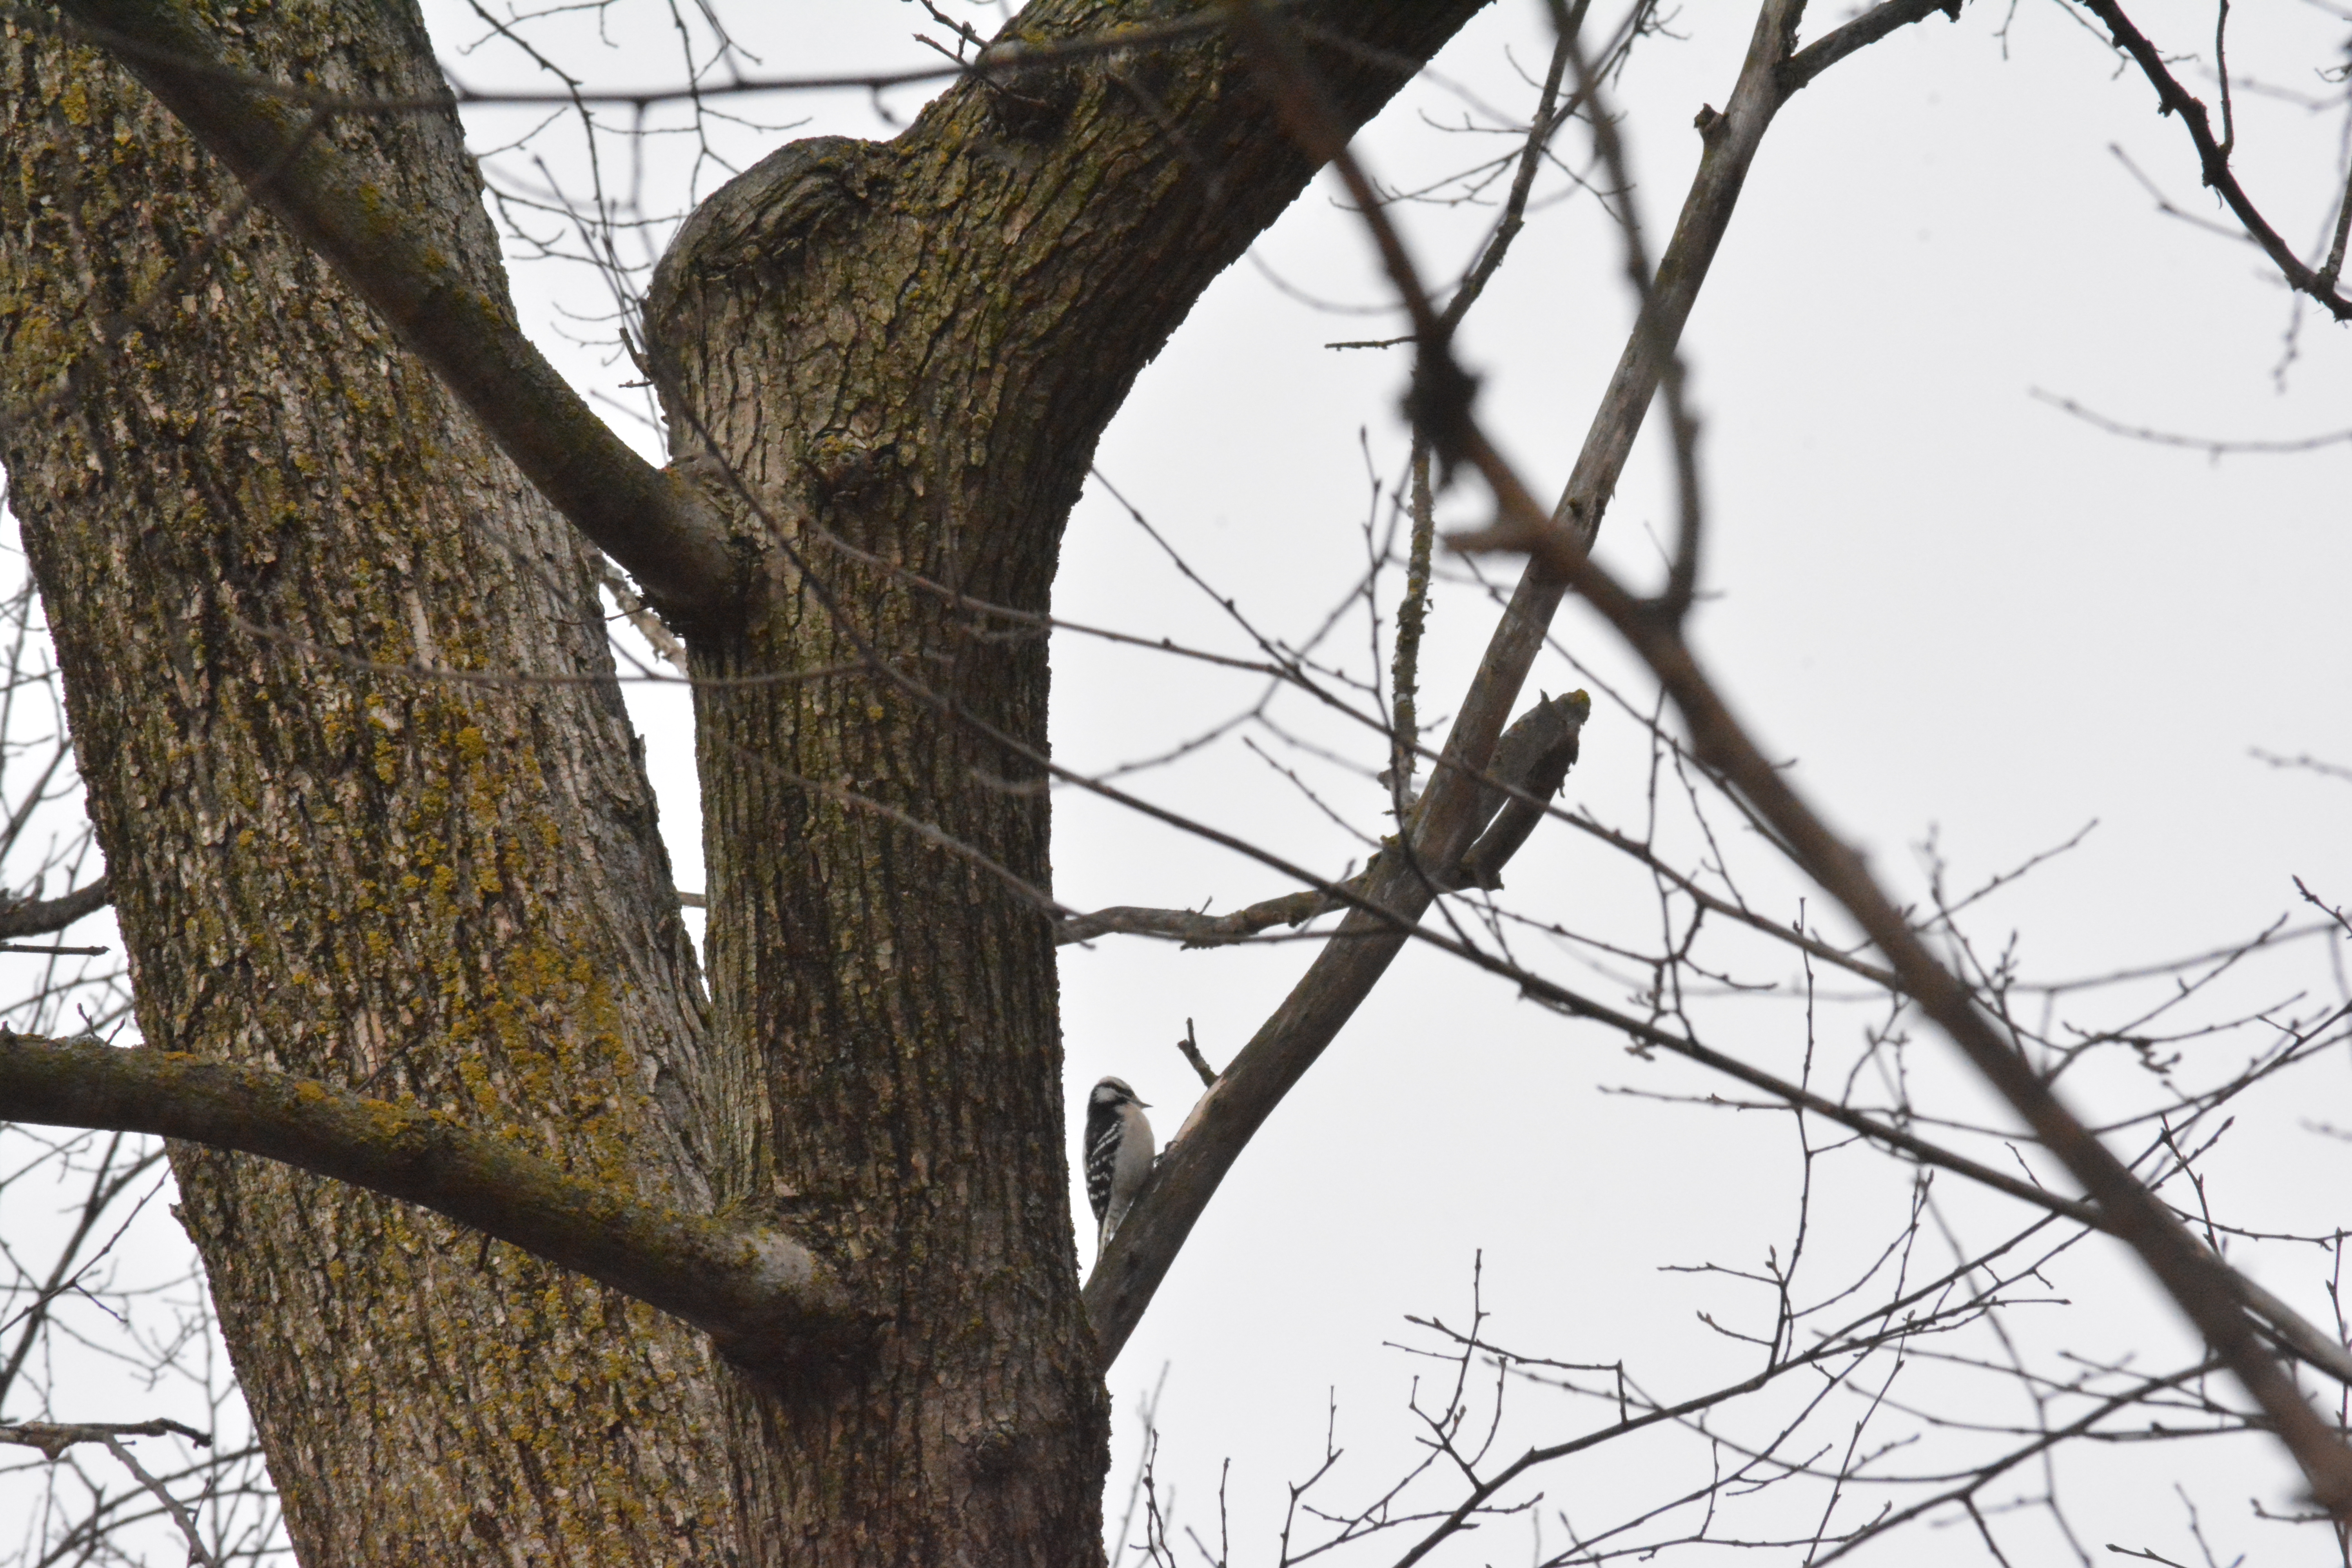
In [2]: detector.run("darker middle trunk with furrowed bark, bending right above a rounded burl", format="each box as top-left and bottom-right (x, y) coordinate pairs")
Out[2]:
(647, 0), (1477, 1566)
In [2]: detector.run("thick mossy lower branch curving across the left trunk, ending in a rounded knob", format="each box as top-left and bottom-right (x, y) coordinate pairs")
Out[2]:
(0, 1034), (856, 1373)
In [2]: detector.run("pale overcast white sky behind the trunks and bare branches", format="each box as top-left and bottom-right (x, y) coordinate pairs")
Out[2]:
(14, 0), (2352, 1563)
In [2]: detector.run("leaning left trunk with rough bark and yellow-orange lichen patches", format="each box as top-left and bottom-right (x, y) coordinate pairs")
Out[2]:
(0, 0), (741, 1568)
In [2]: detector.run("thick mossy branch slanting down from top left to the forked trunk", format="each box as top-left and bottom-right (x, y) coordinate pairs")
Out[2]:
(59, 0), (734, 621)
